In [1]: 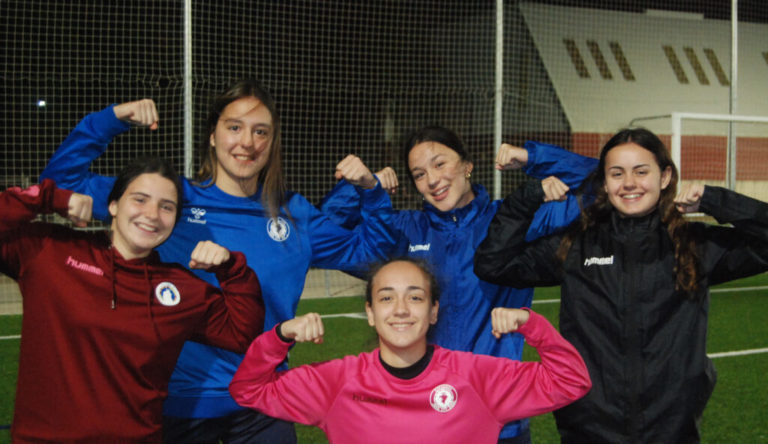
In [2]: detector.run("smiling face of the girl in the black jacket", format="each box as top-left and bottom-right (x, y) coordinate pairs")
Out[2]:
(604, 142), (672, 217)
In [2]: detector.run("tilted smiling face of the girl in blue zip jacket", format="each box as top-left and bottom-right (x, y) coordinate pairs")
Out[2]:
(408, 142), (475, 211)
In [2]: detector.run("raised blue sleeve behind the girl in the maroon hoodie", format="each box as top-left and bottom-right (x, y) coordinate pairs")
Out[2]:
(40, 105), (130, 221)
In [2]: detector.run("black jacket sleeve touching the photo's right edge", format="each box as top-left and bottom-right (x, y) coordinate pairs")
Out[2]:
(700, 186), (768, 285)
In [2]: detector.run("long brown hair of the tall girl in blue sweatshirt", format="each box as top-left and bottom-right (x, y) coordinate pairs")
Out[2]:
(195, 79), (287, 218)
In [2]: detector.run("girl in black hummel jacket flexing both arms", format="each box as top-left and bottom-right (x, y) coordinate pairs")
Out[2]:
(475, 129), (768, 443)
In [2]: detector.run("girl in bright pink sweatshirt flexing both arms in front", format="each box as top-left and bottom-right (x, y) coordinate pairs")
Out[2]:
(230, 259), (591, 443)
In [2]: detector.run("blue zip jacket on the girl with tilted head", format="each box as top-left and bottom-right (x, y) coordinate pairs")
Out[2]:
(321, 142), (597, 438)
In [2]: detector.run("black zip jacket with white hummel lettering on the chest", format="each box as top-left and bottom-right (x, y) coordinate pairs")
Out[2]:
(475, 181), (768, 443)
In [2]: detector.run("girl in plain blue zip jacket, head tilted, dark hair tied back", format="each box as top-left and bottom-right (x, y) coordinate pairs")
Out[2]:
(321, 127), (597, 442)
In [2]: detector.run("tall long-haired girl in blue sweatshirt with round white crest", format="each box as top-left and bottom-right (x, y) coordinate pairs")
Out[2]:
(42, 81), (392, 442)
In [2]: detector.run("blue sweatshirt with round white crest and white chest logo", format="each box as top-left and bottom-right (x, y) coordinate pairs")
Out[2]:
(41, 107), (392, 418)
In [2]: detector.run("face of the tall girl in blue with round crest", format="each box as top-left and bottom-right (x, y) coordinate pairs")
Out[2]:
(210, 96), (273, 196)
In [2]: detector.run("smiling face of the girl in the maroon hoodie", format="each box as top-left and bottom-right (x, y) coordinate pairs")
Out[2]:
(109, 173), (178, 259)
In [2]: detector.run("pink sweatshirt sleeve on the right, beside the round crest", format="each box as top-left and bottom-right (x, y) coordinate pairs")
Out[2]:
(472, 312), (592, 423)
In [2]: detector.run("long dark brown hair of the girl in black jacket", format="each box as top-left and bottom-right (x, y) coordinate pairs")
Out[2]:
(557, 128), (701, 297)
